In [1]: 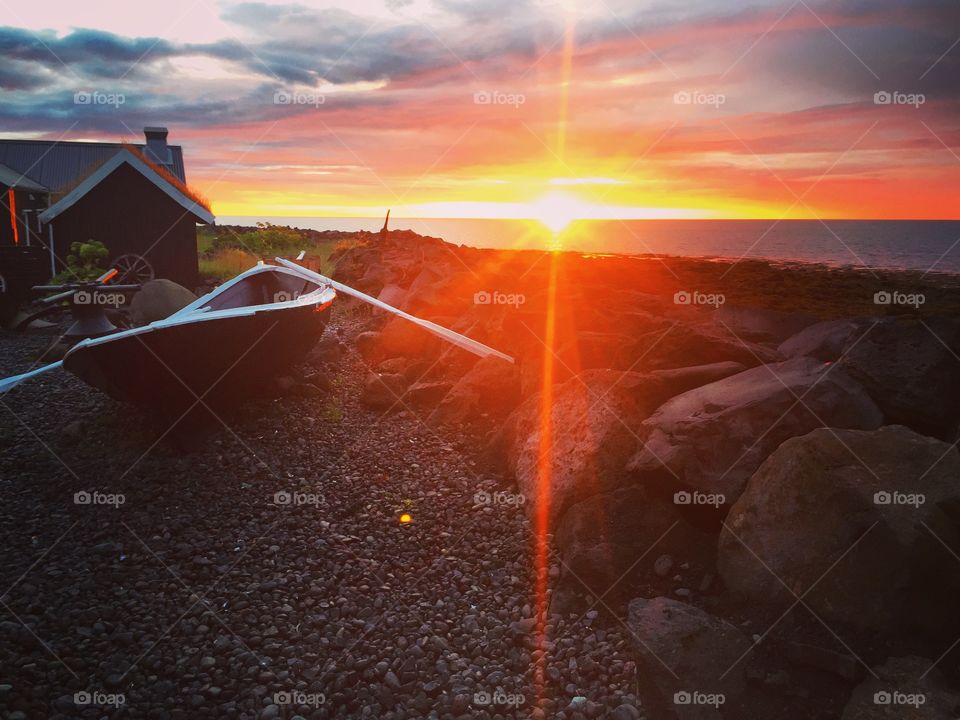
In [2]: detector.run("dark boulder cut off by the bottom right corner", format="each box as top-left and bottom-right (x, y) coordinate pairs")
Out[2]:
(841, 656), (960, 720)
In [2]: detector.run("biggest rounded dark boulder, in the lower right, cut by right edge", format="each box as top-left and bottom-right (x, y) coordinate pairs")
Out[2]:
(718, 426), (960, 634)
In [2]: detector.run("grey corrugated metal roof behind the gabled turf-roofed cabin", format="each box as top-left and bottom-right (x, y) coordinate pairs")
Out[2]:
(0, 139), (187, 192)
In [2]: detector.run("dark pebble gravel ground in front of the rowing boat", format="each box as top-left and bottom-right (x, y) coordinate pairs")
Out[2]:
(0, 316), (641, 720)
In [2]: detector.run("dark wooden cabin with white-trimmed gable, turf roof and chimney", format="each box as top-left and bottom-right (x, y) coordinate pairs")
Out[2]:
(0, 127), (215, 288)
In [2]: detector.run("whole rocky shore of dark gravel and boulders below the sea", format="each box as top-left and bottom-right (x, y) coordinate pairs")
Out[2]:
(0, 232), (960, 720)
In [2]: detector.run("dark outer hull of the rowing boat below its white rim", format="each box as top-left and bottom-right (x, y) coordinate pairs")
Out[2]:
(63, 303), (330, 415)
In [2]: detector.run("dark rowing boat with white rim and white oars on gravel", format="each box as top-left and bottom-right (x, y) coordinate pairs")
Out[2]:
(0, 258), (513, 416)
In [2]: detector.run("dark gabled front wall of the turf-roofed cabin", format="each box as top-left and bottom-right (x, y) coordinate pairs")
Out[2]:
(52, 164), (198, 290)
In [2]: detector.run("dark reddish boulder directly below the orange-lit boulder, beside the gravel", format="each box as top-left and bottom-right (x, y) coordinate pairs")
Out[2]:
(555, 486), (716, 607)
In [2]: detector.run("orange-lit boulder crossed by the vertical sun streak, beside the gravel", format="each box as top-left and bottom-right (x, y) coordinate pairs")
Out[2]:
(504, 370), (669, 521)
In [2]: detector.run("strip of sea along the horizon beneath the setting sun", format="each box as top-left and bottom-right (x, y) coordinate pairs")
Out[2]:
(218, 216), (960, 273)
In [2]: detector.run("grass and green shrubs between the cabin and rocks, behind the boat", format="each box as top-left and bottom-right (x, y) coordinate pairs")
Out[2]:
(197, 223), (364, 282)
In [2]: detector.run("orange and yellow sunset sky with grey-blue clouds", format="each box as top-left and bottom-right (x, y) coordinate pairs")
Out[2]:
(0, 0), (960, 219)
